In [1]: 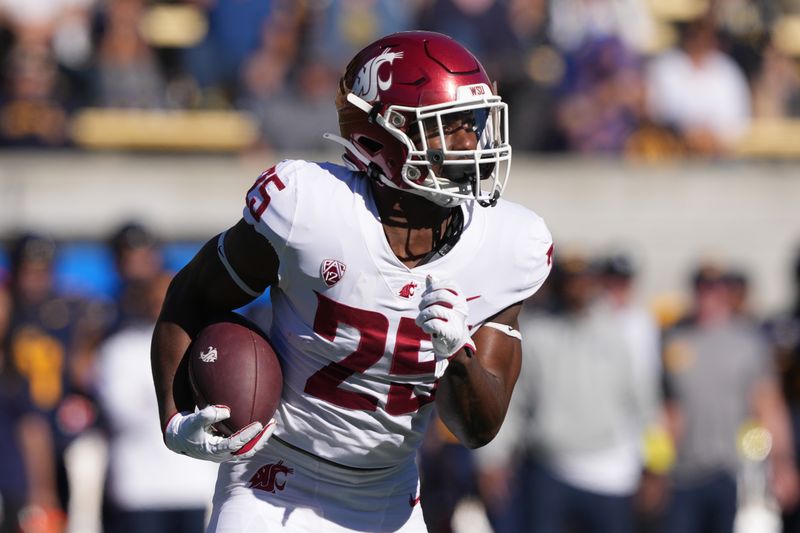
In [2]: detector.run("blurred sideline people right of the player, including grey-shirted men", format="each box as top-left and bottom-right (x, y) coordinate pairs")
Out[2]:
(421, 251), (800, 533)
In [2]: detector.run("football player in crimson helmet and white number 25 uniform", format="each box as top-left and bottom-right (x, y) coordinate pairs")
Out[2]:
(152, 31), (552, 533)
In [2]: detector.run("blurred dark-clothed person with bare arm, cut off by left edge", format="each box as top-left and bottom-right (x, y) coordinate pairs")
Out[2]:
(0, 279), (64, 533)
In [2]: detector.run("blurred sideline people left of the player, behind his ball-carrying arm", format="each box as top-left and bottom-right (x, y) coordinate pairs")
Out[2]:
(0, 223), (222, 533)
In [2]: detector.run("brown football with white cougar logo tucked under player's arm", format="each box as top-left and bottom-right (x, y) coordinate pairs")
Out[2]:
(188, 315), (283, 436)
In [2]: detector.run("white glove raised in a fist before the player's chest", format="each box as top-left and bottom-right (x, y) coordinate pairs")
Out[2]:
(416, 276), (475, 360)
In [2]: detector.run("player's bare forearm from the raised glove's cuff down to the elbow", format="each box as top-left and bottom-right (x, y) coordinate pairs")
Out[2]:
(436, 350), (508, 448)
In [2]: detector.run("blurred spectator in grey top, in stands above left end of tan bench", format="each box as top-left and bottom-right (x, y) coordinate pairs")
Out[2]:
(95, 0), (166, 109)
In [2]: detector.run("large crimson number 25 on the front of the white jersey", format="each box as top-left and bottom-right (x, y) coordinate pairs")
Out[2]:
(305, 293), (436, 416)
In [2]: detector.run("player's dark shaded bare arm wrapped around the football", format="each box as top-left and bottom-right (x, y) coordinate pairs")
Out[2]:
(151, 220), (278, 428)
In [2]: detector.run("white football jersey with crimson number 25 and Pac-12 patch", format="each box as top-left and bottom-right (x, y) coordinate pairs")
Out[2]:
(244, 161), (552, 468)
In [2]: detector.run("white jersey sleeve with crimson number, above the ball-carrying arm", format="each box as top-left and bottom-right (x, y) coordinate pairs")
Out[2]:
(243, 161), (303, 261)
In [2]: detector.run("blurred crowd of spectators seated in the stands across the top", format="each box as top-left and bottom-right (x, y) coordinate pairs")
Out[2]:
(0, 0), (800, 160)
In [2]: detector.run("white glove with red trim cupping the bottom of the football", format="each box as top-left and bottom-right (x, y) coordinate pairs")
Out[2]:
(164, 405), (275, 463)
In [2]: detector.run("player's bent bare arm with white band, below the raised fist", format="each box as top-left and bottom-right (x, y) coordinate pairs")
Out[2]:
(436, 303), (522, 448)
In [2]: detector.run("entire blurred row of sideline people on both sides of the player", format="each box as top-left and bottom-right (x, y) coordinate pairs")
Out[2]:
(0, 222), (800, 533)
